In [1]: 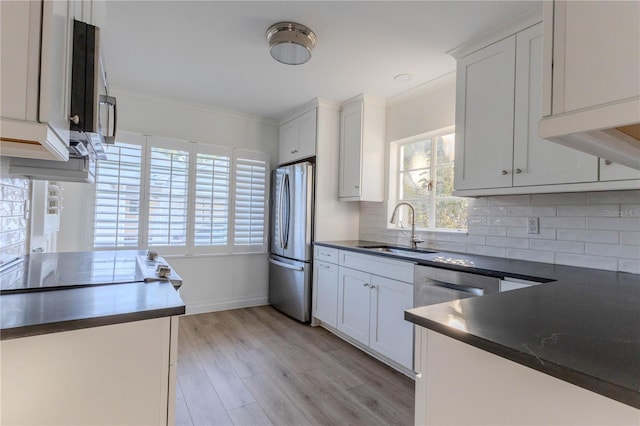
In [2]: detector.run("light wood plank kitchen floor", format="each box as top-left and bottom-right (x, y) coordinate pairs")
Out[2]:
(176, 306), (414, 426)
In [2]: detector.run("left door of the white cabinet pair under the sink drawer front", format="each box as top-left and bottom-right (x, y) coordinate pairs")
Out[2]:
(338, 267), (371, 345)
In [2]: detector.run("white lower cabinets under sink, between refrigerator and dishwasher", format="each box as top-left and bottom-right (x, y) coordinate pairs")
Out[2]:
(312, 246), (414, 372)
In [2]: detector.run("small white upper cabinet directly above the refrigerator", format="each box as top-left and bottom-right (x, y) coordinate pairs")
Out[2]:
(279, 108), (317, 164)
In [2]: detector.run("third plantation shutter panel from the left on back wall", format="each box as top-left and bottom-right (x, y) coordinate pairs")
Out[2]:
(193, 145), (231, 252)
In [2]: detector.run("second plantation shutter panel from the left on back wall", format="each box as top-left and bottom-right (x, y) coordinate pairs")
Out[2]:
(147, 137), (189, 251)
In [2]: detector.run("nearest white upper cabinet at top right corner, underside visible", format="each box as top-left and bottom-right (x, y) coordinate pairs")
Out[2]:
(540, 0), (640, 168)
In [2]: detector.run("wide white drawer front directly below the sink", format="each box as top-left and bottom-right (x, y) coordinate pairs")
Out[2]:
(340, 250), (414, 284)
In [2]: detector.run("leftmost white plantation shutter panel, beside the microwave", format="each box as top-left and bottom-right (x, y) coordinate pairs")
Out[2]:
(93, 135), (144, 248)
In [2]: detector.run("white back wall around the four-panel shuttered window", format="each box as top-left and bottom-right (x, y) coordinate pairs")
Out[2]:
(58, 91), (278, 313)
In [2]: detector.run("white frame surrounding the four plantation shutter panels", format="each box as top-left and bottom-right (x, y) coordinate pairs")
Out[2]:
(91, 130), (270, 256)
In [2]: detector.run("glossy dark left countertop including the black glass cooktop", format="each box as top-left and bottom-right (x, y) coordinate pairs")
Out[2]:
(0, 250), (185, 340)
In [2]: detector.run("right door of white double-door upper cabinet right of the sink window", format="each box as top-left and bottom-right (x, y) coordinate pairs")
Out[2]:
(513, 23), (598, 186)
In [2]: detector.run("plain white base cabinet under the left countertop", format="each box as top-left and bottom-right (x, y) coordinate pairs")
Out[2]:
(0, 318), (178, 425)
